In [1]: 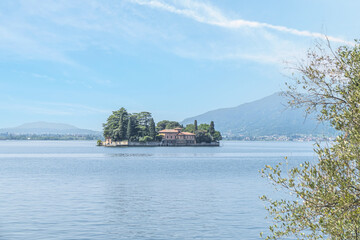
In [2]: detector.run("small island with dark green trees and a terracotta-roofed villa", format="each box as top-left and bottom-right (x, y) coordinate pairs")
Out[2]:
(97, 108), (222, 147)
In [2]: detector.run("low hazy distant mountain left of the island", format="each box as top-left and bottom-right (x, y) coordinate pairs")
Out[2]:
(0, 122), (101, 135)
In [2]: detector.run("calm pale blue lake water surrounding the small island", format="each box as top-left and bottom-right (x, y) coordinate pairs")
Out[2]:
(0, 141), (314, 240)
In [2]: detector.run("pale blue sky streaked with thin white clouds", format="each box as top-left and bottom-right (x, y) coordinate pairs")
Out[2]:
(0, 0), (360, 130)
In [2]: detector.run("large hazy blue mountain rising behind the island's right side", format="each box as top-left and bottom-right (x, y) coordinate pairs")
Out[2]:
(181, 93), (335, 137)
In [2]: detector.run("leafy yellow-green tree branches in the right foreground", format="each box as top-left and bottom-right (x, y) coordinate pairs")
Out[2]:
(262, 42), (360, 240)
